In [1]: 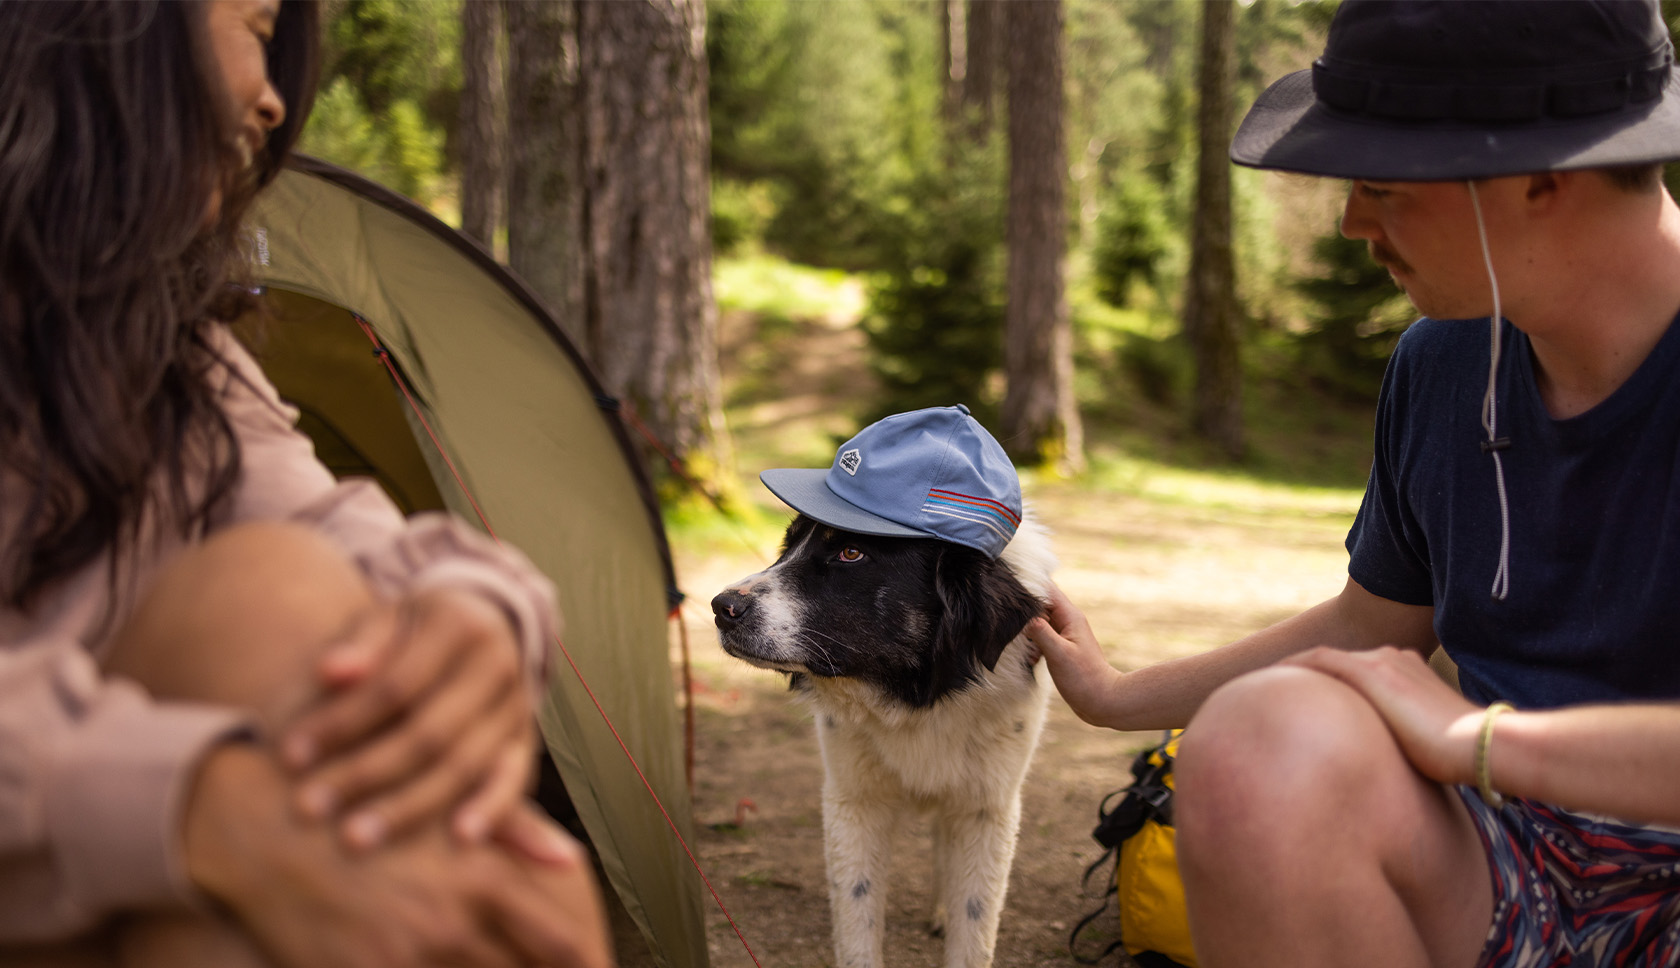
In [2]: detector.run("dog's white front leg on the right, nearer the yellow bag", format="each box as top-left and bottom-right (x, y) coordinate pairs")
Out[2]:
(934, 800), (1021, 968)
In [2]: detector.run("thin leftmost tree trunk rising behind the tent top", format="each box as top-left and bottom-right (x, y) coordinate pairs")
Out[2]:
(459, 0), (506, 252)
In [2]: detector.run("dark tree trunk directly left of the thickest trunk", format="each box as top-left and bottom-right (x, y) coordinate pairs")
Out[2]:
(500, 0), (588, 346)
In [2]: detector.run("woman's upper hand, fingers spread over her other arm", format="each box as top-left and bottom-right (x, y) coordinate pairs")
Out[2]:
(281, 588), (536, 849)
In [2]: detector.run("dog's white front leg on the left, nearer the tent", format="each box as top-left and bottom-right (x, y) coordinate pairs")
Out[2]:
(823, 780), (897, 968)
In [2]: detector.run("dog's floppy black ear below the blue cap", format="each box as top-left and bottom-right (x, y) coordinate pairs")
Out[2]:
(934, 545), (1045, 671)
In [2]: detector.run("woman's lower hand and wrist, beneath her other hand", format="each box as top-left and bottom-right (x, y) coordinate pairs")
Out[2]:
(181, 744), (612, 968)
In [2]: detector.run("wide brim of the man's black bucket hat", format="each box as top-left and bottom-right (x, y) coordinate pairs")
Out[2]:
(1231, 71), (1680, 182)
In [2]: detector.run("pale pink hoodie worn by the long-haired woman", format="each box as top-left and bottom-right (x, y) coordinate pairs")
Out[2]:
(0, 329), (558, 946)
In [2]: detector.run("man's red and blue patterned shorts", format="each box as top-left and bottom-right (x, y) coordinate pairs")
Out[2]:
(1458, 787), (1680, 968)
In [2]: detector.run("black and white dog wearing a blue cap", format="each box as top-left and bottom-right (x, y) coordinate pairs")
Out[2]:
(712, 408), (1055, 968)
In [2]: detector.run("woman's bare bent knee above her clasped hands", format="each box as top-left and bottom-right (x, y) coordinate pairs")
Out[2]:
(104, 523), (376, 719)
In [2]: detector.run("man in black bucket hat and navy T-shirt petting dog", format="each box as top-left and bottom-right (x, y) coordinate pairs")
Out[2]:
(1030, 0), (1680, 968)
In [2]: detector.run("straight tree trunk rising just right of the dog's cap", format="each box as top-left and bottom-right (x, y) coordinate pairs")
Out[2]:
(1003, 0), (1084, 472)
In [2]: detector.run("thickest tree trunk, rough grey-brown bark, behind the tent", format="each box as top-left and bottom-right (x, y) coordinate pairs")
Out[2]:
(576, 0), (732, 484)
